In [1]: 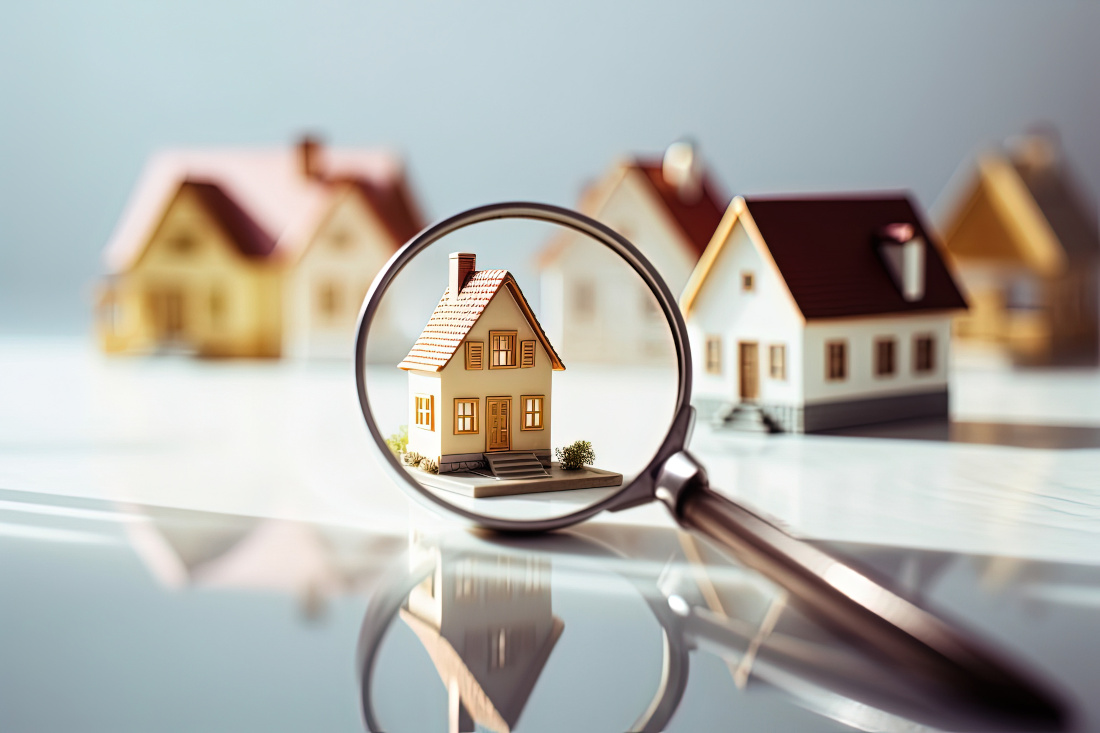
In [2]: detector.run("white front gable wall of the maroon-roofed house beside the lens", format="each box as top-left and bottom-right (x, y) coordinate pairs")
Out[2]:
(688, 221), (803, 406)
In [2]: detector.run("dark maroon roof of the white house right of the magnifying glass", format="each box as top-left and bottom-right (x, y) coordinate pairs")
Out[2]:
(683, 195), (966, 320)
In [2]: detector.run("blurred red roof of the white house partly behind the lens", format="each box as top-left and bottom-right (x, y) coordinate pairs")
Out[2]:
(538, 152), (729, 267)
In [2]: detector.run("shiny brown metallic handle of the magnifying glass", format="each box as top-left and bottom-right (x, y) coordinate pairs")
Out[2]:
(658, 452), (1065, 730)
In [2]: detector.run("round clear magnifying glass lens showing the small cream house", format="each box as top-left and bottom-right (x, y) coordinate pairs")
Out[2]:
(363, 214), (679, 522)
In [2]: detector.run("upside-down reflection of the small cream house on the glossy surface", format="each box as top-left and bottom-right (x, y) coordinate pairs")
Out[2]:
(400, 548), (565, 733)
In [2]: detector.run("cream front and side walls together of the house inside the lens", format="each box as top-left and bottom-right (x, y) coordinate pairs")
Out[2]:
(409, 281), (553, 462)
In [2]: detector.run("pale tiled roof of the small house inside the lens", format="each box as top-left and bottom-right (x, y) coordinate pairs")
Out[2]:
(397, 270), (565, 372)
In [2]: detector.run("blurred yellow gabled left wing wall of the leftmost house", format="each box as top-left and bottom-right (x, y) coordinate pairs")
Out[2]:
(97, 182), (283, 357)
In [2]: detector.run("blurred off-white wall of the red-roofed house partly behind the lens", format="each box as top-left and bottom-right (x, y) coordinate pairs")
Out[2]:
(540, 163), (695, 364)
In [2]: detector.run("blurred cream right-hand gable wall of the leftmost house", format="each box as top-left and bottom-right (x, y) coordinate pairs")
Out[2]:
(285, 188), (404, 359)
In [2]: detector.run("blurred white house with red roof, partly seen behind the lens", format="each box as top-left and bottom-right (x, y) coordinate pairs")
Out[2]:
(538, 142), (729, 364)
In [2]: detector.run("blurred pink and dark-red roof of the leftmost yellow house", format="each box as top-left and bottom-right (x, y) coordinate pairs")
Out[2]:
(105, 146), (420, 272)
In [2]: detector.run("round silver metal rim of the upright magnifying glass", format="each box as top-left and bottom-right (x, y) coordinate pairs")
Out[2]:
(355, 201), (694, 532)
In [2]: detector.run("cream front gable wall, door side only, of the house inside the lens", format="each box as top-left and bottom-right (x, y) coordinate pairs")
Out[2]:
(440, 288), (553, 456)
